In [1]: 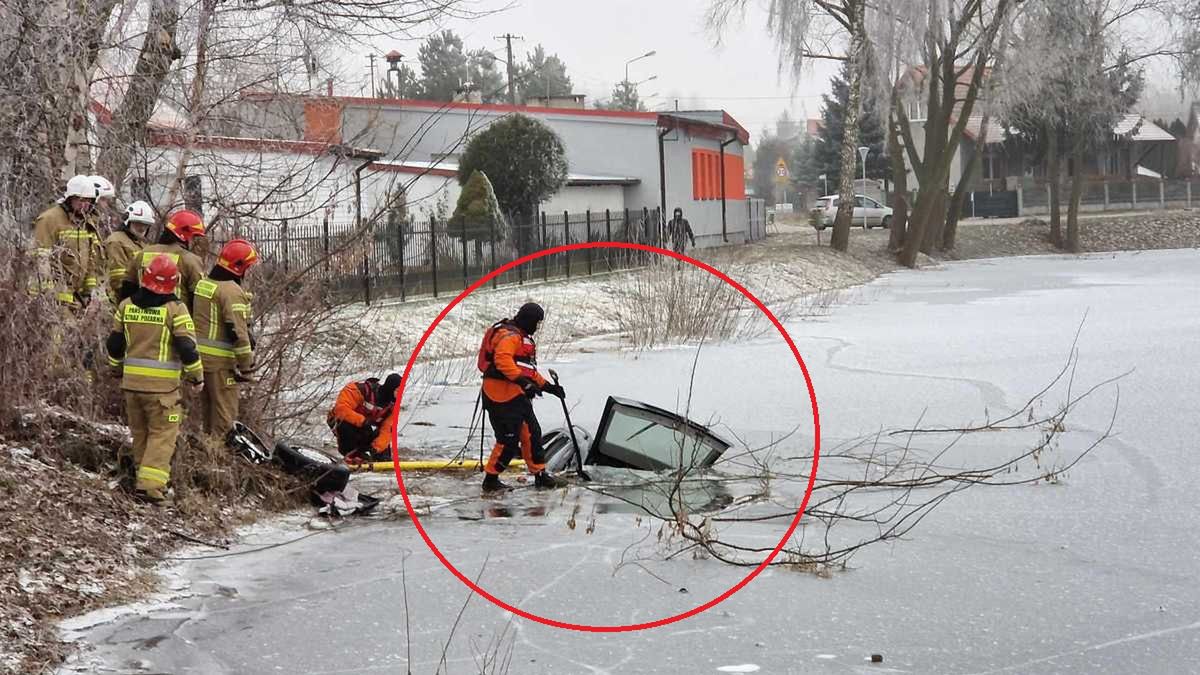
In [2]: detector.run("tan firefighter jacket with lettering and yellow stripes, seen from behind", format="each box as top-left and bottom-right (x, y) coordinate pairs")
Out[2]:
(104, 288), (204, 393)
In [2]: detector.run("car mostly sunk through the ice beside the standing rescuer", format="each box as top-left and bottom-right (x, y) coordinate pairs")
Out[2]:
(542, 396), (732, 473)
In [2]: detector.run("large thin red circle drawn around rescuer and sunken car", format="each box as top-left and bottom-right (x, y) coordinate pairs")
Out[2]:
(391, 241), (821, 633)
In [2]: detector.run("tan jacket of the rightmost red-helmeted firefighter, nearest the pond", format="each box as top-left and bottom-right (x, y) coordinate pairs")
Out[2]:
(192, 279), (254, 372)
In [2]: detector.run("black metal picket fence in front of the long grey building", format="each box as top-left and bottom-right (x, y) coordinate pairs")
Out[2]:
(225, 208), (664, 303)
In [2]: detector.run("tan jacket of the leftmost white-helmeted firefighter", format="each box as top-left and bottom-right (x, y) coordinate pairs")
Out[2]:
(30, 204), (102, 304)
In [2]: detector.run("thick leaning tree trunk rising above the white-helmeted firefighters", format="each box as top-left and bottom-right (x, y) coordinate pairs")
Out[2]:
(97, 0), (181, 190)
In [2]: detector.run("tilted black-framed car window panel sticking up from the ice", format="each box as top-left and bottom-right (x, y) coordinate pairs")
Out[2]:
(588, 398), (730, 471)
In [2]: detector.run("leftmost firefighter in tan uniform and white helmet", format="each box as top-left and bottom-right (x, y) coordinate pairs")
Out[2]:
(30, 175), (101, 309)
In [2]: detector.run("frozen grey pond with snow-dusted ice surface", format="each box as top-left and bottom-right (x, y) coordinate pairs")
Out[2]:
(66, 251), (1200, 674)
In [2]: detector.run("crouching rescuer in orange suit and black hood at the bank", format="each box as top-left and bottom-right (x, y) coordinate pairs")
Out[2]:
(325, 372), (401, 461)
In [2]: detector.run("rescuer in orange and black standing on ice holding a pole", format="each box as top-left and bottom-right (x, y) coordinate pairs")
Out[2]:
(479, 303), (566, 492)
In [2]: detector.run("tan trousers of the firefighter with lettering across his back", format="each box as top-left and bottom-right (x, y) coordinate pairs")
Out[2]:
(125, 389), (182, 494)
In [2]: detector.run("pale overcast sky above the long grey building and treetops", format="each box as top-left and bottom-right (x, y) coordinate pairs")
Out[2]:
(360, 0), (836, 143)
